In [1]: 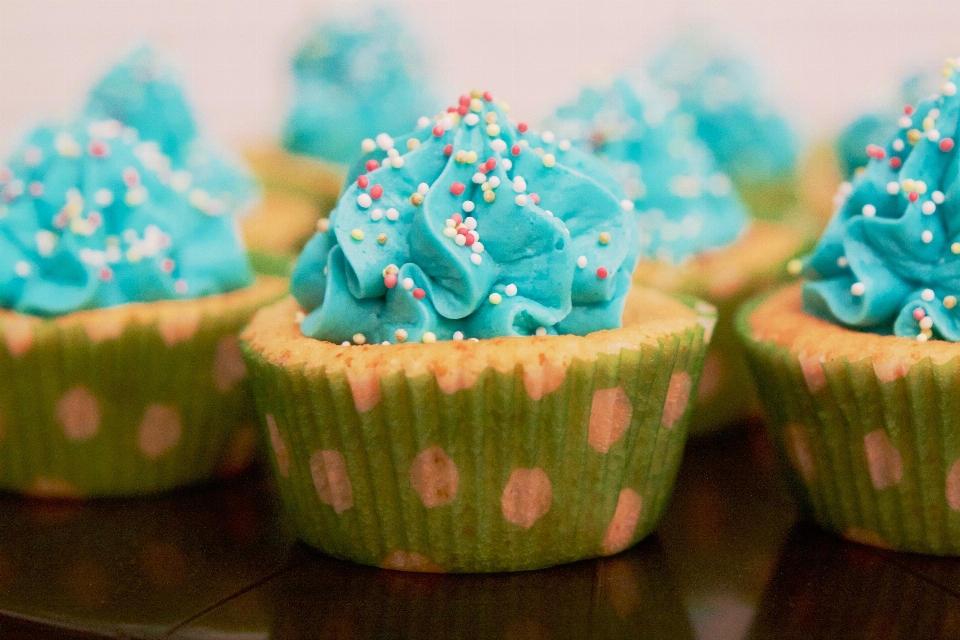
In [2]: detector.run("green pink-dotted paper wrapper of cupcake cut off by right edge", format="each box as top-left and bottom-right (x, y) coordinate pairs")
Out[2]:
(737, 290), (960, 555)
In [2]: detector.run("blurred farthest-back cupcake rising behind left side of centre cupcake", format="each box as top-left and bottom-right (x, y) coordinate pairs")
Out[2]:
(245, 7), (440, 254)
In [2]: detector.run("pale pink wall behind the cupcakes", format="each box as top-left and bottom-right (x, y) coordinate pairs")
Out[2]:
(0, 0), (960, 147)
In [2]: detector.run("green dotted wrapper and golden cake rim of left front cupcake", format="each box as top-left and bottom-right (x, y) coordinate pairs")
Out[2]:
(0, 278), (285, 497)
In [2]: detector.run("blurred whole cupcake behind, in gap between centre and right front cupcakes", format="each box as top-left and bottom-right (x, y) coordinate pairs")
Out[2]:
(549, 78), (802, 433)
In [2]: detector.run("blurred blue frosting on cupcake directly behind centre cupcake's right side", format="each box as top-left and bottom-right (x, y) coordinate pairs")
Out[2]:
(550, 78), (748, 262)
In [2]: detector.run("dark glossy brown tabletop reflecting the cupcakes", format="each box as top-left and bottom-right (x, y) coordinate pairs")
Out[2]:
(0, 425), (960, 640)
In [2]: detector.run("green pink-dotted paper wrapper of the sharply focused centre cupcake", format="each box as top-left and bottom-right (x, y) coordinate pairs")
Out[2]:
(242, 294), (715, 572)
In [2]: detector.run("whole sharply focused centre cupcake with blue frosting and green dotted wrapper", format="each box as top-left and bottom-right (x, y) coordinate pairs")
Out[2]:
(241, 92), (715, 572)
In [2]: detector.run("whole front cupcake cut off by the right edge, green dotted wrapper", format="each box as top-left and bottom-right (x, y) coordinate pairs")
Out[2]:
(737, 60), (960, 555)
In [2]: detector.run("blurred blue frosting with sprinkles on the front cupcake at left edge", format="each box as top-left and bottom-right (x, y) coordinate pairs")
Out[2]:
(0, 119), (253, 316)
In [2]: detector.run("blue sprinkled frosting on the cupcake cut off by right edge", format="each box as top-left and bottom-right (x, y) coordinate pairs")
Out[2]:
(803, 60), (960, 342)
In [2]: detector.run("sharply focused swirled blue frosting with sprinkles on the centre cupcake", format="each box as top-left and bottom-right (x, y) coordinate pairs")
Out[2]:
(292, 92), (637, 344)
